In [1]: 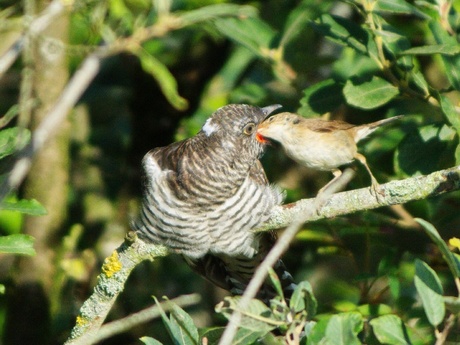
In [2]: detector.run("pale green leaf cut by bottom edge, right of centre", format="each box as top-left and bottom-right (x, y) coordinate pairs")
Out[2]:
(369, 315), (410, 345)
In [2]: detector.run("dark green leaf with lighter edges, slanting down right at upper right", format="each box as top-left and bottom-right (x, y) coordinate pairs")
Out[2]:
(310, 14), (378, 57)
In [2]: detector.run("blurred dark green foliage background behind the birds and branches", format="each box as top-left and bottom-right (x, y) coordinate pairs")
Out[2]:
(0, 0), (460, 344)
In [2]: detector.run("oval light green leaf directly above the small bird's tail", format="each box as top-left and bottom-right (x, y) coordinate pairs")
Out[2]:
(343, 76), (399, 109)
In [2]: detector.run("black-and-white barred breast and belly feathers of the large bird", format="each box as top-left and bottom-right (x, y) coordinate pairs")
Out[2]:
(135, 149), (283, 258)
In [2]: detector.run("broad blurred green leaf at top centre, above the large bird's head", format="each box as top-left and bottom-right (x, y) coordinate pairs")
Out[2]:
(215, 18), (276, 57)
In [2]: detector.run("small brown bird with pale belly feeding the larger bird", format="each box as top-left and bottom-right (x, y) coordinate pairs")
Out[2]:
(257, 113), (403, 194)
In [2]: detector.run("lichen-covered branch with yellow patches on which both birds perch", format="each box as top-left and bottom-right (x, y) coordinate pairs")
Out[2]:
(66, 166), (460, 345)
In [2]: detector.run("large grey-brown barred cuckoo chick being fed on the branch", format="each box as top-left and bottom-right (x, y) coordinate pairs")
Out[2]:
(135, 105), (292, 300)
